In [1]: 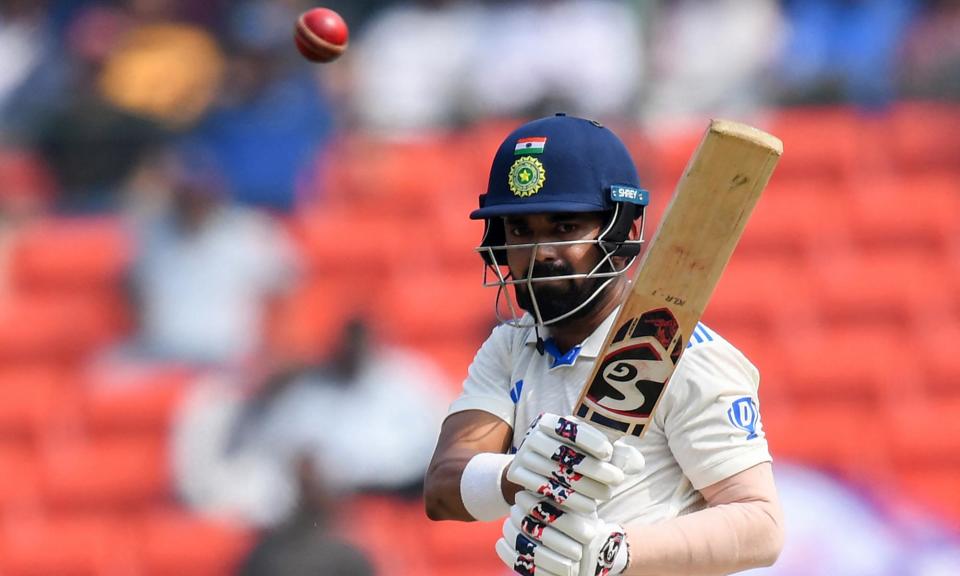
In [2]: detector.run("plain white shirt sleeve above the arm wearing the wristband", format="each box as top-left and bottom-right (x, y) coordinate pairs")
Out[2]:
(448, 325), (515, 427)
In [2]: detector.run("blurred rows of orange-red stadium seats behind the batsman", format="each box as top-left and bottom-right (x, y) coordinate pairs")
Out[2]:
(0, 104), (960, 575)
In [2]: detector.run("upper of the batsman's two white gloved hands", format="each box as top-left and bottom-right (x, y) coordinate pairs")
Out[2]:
(507, 413), (643, 513)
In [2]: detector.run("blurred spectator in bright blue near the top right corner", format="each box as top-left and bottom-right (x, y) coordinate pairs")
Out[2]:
(777, 0), (917, 106)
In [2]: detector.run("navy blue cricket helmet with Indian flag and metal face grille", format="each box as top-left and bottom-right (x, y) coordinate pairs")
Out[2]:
(470, 114), (649, 324)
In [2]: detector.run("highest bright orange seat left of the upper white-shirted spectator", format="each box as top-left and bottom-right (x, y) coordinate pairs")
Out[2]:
(11, 217), (132, 289)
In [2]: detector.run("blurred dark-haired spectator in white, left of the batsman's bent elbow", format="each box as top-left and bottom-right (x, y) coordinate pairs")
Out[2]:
(173, 320), (449, 526)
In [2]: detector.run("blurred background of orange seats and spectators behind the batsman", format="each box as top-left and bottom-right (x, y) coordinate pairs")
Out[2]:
(0, 0), (960, 576)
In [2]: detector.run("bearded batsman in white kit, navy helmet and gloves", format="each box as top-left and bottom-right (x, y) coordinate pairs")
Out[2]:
(425, 114), (783, 576)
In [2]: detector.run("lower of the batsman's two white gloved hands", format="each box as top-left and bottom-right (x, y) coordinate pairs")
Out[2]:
(496, 492), (630, 576)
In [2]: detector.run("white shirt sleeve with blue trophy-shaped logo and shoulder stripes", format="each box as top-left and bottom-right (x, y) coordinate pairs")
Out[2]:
(654, 339), (771, 490)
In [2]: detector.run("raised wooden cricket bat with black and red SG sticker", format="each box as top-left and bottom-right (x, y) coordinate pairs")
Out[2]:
(574, 120), (783, 437)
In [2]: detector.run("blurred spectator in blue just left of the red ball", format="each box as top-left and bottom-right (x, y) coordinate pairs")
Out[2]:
(189, 0), (333, 211)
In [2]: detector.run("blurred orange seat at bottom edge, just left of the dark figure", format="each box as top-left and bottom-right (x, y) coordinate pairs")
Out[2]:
(134, 508), (254, 576)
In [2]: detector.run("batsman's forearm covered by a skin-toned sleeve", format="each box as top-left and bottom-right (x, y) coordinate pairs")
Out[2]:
(625, 501), (783, 576)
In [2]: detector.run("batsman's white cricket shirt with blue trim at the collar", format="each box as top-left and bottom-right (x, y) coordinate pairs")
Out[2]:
(449, 310), (771, 523)
